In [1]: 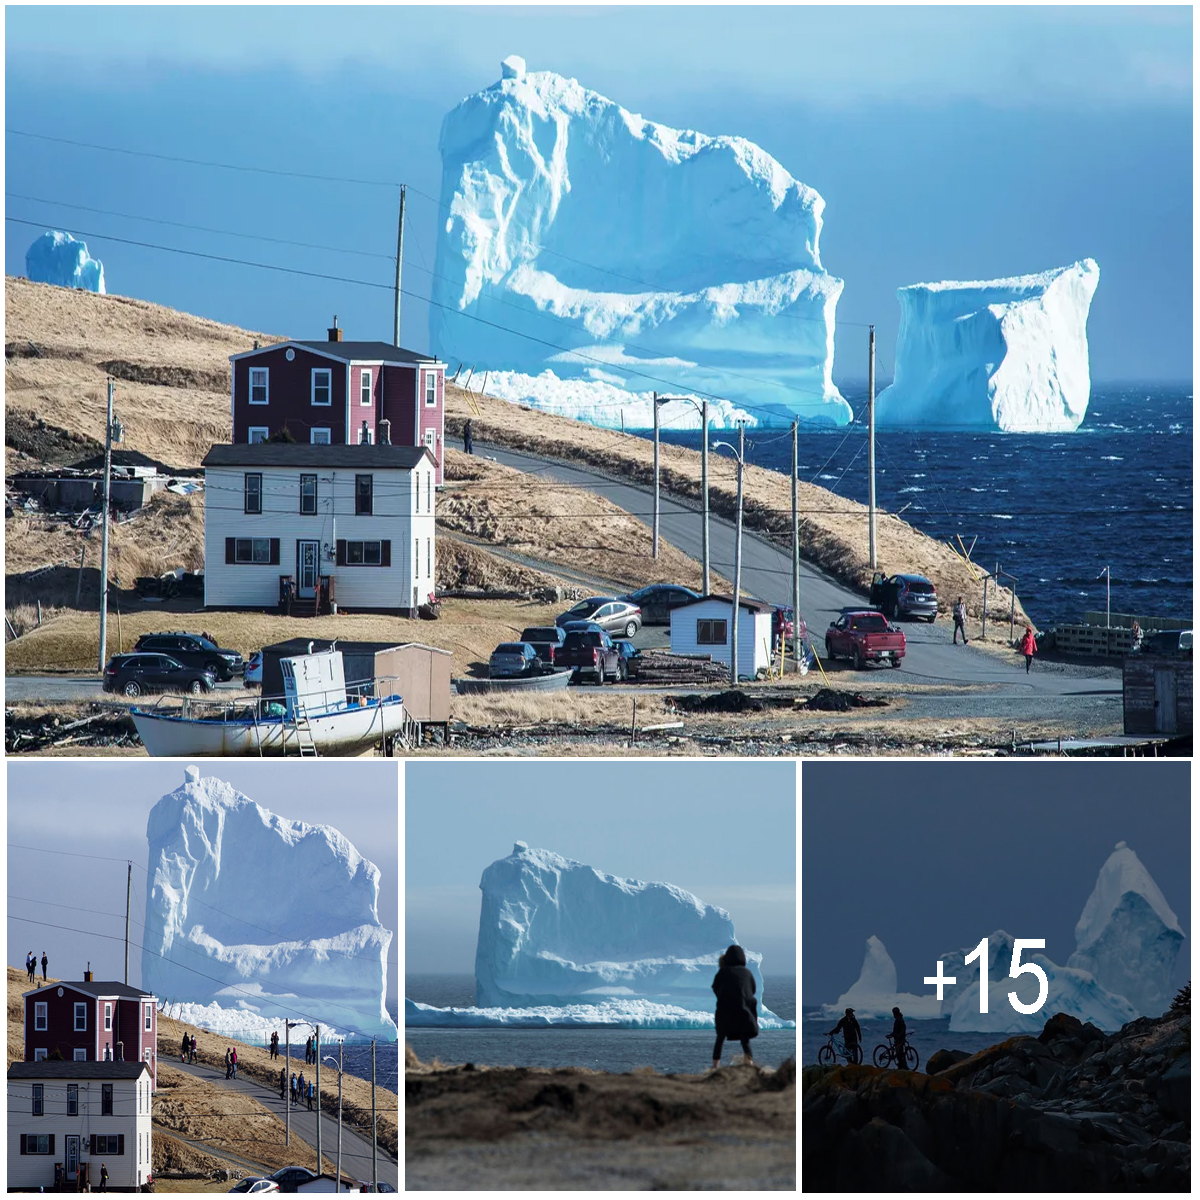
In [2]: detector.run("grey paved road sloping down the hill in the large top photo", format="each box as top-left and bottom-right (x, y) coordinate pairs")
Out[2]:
(476, 443), (1121, 719)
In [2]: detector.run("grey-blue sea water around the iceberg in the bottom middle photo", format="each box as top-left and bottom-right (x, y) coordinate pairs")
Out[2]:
(404, 974), (797, 1074)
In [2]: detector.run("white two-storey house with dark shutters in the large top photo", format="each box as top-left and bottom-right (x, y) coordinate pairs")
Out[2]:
(203, 442), (437, 614)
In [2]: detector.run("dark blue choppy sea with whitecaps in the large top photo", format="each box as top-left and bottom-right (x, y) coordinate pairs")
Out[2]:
(662, 384), (1192, 628)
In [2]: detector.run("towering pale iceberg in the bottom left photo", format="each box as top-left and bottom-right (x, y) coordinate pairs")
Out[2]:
(142, 767), (396, 1039)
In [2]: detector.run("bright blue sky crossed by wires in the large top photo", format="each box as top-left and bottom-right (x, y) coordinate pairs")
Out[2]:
(5, 6), (1192, 382)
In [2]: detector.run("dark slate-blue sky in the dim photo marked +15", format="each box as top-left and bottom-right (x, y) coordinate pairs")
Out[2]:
(800, 758), (1192, 1006)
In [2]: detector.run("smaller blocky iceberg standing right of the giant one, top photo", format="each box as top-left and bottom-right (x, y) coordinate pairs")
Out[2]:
(875, 258), (1100, 433)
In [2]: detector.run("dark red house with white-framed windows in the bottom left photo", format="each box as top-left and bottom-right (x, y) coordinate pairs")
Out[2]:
(24, 971), (158, 1088)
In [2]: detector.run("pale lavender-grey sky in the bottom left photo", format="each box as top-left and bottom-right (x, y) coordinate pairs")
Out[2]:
(7, 760), (400, 1003)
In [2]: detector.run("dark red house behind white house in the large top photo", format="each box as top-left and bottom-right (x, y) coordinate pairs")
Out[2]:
(229, 318), (446, 485)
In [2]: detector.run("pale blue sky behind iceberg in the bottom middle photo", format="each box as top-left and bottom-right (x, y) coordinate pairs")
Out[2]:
(404, 758), (796, 974)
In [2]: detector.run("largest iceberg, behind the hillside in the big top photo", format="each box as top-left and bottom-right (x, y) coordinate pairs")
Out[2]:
(430, 58), (851, 425)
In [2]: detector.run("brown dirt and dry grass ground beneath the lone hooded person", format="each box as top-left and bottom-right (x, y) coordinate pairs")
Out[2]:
(404, 1051), (796, 1190)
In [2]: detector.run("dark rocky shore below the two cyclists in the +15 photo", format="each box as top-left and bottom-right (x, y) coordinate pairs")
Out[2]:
(803, 1010), (1192, 1192)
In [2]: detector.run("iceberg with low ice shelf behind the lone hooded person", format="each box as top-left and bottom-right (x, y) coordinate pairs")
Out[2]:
(404, 841), (794, 1028)
